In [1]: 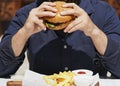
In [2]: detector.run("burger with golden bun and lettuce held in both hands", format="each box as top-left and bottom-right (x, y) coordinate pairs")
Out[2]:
(43, 1), (74, 30)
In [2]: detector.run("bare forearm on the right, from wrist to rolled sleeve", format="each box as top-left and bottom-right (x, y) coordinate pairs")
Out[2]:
(90, 27), (108, 55)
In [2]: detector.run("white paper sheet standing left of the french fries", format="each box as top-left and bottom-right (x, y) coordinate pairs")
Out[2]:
(22, 70), (49, 86)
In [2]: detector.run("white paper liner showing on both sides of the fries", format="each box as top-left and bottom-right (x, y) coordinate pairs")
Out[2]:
(22, 70), (99, 86)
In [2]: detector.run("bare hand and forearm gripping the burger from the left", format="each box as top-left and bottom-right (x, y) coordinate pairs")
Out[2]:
(12, 2), (57, 57)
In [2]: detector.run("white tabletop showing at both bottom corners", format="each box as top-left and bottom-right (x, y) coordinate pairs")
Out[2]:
(0, 78), (120, 86)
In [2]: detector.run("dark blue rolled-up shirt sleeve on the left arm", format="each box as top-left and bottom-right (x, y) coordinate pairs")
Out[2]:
(0, 8), (25, 77)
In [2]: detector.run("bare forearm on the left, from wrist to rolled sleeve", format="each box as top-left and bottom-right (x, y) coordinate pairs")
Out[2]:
(12, 28), (30, 57)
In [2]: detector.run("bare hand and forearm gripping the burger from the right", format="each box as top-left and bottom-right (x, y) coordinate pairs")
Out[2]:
(61, 3), (107, 55)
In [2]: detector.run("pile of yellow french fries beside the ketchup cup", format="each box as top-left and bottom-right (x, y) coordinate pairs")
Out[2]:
(43, 71), (75, 86)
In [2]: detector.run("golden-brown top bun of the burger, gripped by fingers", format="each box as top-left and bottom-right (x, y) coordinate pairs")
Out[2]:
(44, 1), (73, 23)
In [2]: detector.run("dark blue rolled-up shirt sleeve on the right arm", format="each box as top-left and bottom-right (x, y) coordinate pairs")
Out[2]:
(101, 4), (120, 78)
